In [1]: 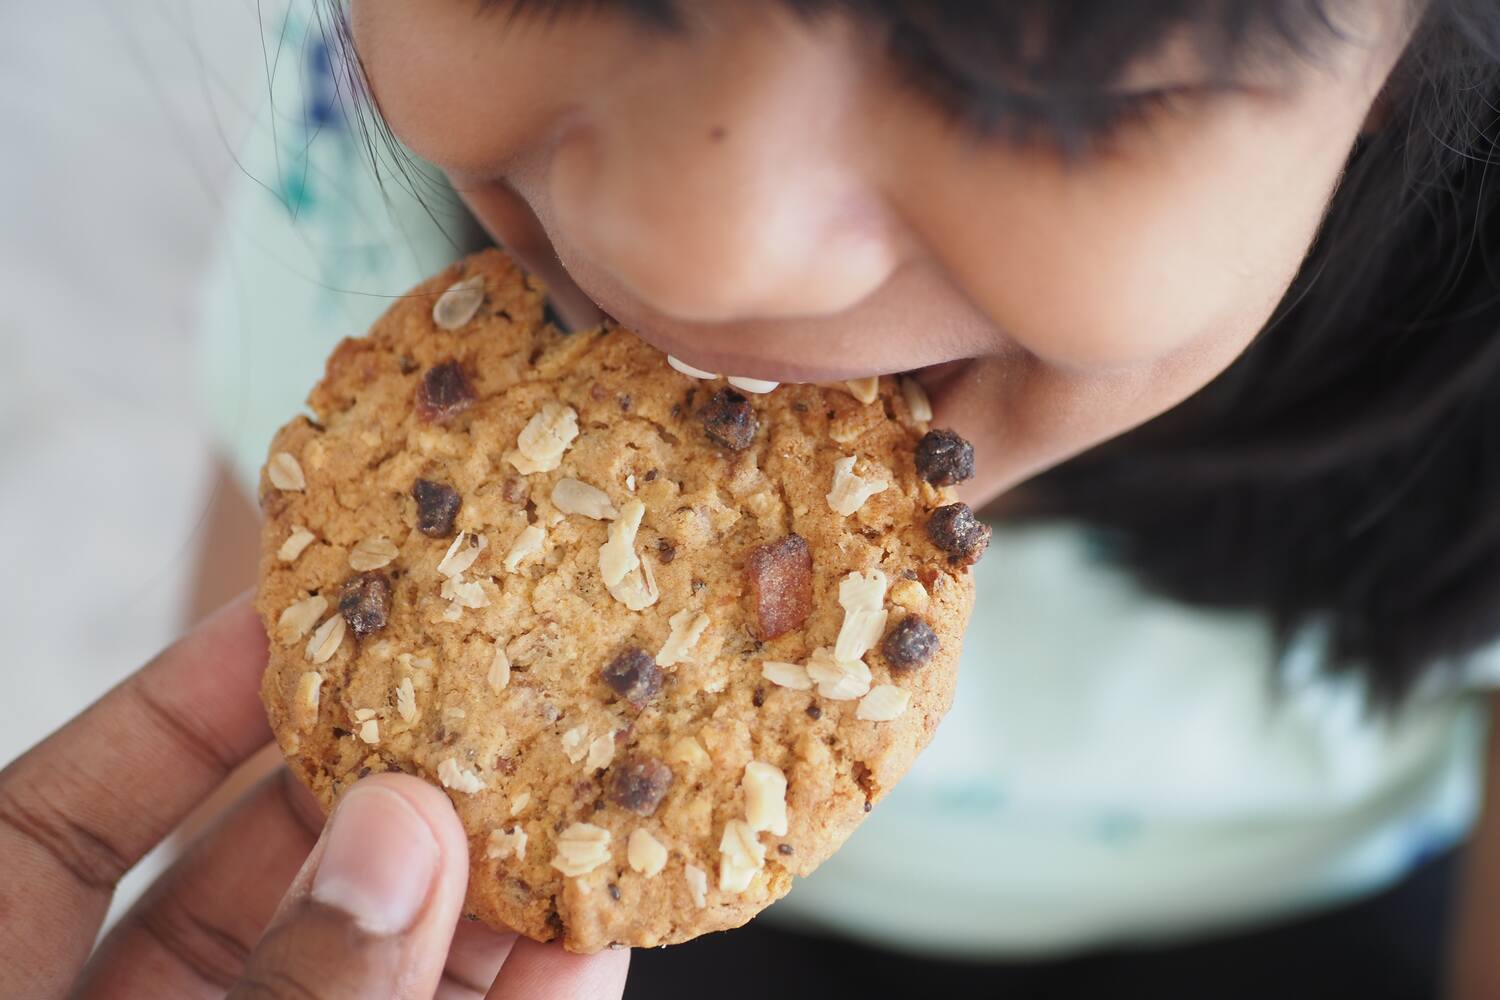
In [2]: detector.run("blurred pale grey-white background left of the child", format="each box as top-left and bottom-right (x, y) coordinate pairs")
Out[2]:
(0, 0), (267, 906)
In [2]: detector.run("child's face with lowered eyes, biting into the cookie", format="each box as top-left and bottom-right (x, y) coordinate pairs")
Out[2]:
(353, 0), (1407, 502)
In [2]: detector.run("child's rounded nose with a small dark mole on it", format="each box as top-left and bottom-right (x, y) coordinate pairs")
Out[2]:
(548, 19), (902, 322)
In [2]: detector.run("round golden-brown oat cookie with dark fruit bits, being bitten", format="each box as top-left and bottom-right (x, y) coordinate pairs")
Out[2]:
(258, 252), (984, 952)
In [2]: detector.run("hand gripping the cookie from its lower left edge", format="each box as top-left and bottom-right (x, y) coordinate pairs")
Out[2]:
(0, 600), (629, 999)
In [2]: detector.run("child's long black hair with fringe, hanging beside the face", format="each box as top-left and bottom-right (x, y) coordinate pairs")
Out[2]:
(331, 0), (1500, 705)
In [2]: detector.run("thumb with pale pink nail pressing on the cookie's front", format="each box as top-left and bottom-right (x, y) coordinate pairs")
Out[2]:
(230, 774), (468, 1000)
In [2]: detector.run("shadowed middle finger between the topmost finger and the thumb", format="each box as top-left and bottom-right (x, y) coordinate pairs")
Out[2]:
(74, 771), (323, 999)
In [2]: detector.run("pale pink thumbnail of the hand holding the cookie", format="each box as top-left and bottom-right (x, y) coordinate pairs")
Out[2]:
(312, 784), (438, 934)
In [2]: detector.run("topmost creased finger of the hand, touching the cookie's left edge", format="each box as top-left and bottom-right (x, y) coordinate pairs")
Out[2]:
(0, 598), (270, 997)
